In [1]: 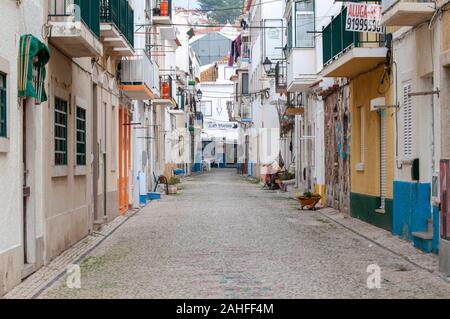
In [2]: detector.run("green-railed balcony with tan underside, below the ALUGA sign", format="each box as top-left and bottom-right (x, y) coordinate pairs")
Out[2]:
(321, 9), (388, 77)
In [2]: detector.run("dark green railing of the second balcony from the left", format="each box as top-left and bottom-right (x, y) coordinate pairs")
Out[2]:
(101, 0), (134, 47)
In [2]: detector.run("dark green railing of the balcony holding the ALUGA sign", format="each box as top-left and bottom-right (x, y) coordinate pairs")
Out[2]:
(322, 9), (385, 66)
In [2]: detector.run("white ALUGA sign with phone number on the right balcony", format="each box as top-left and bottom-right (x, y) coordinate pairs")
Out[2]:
(345, 2), (385, 33)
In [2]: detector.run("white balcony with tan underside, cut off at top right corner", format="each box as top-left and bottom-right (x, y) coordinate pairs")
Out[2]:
(382, 0), (436, 27)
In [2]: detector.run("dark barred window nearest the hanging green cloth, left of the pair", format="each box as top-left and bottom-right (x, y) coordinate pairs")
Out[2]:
(55, 97), (67, 166)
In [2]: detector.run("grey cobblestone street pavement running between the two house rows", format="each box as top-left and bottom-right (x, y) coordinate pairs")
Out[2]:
(40, 170), (450, 298)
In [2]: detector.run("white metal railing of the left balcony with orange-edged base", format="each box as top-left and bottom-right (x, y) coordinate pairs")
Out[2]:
(120, 51), (159, 93)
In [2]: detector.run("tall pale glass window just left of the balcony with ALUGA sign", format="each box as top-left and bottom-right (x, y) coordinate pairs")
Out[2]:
(295, 0), (315, 48)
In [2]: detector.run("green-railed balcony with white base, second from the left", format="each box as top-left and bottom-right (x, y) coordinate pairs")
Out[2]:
(100, 0), (134, 56)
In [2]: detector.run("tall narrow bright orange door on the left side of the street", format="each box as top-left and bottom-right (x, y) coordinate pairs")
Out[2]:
(118, 107), (131, 214)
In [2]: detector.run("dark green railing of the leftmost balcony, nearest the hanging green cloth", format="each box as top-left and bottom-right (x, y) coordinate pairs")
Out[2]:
(49, 0), (100, 38)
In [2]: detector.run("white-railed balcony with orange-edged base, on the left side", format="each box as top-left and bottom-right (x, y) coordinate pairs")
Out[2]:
(120, 51), (159, 101)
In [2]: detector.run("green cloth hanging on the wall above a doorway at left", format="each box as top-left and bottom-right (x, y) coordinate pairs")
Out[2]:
(18, 34), (50, 105)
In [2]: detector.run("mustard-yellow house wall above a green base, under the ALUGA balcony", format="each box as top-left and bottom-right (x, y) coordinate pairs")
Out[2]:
(350, 66), (395, 198)
